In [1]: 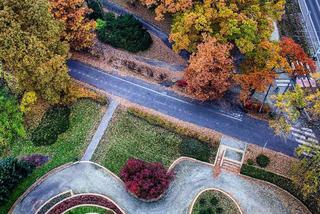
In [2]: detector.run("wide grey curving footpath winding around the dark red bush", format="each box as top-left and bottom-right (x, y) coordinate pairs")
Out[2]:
(13, 159), (310, 214)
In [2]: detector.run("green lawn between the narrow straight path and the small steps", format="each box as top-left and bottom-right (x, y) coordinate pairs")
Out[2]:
(94, 111), (216, 175)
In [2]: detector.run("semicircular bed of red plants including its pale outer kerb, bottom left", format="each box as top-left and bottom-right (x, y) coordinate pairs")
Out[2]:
(47, 193), (125, 214)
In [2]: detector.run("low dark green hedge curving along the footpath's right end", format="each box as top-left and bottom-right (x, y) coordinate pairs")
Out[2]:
(241, 164), (320, 213)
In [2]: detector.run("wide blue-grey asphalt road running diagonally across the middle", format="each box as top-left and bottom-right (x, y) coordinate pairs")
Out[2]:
(68, 61), (298, 156)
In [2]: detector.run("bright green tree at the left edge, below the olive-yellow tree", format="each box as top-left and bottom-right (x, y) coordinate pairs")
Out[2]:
(0, 88), (26, 154)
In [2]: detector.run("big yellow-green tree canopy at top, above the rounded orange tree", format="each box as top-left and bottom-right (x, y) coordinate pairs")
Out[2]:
(170, 0), (285, 54)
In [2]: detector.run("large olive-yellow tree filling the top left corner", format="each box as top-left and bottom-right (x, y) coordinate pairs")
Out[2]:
(0, 0), (70, 104)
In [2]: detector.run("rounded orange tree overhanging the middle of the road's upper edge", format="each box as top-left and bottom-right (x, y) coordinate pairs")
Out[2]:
(184, 37), (234, 100)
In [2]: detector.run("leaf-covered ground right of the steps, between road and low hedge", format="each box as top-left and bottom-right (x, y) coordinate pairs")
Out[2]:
(244, 144), (298, 177)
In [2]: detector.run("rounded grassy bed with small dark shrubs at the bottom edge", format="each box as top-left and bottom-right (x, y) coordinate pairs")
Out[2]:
(192, 190), (240, 214)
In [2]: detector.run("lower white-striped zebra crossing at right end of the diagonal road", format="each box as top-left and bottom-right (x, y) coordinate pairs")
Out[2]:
(291, 127), (319, 146)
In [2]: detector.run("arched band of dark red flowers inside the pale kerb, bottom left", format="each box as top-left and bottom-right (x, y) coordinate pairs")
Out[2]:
(48, 194), (123, 214)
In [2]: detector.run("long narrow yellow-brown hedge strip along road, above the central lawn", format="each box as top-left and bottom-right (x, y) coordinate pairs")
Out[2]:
(128, 108), (219, 145)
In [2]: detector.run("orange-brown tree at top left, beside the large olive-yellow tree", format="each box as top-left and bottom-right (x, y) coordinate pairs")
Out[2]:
(50, 0), (96, 50)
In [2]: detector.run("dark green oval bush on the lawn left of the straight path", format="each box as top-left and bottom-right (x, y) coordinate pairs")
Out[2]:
(31, 106), (70, 146)
